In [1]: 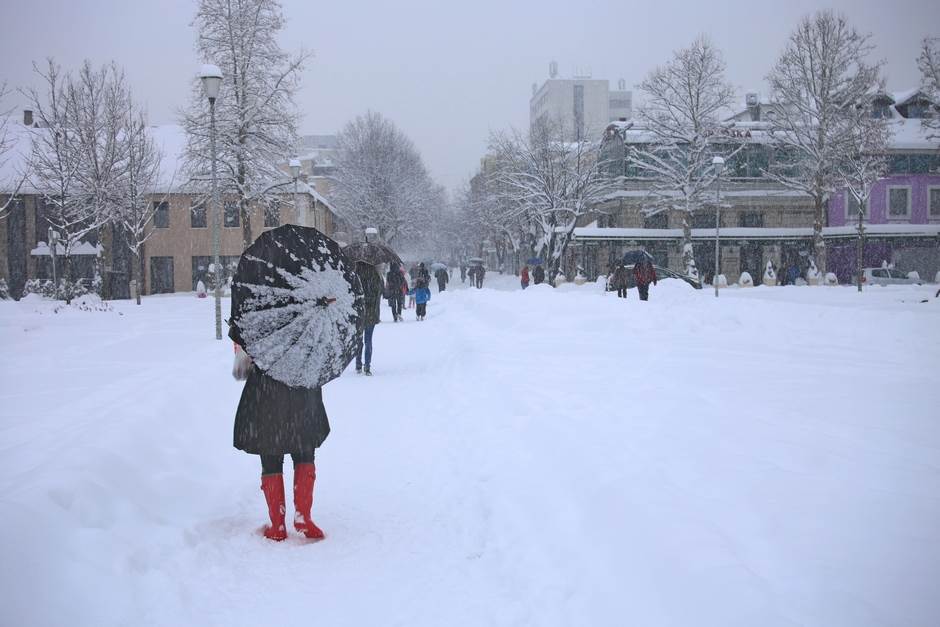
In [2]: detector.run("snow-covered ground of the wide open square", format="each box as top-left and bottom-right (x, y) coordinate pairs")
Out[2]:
(0, 275), (940, 627)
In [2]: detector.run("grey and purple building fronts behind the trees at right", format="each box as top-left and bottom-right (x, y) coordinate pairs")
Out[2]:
(565, 91), (940, 283)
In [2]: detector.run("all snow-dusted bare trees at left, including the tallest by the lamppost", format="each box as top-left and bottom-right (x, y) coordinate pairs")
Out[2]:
(0, 0), (310, 303)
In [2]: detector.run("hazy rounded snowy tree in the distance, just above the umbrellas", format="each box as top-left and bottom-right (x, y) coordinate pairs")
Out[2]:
(332, 111), (441, 243)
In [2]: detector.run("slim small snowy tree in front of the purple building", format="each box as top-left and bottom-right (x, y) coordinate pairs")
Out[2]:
(838, 97), (891, 292)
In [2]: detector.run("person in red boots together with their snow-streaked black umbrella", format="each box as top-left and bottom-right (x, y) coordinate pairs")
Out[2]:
(229, 225), (362, 541)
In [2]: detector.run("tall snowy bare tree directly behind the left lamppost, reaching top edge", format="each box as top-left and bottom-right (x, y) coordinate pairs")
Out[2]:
(183, 0), (310, 248)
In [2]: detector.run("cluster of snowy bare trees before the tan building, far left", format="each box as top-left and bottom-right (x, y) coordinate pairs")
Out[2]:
(23, 59), (161, 301)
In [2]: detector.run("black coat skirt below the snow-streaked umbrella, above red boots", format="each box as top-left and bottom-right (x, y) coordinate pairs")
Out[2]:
(234, 367), (330, 455)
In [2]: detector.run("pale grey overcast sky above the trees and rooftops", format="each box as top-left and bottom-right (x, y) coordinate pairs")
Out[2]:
(0, 0), (940, 188)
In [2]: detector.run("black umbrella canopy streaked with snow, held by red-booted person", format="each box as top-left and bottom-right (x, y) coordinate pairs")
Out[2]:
(229, 224), (363, 388)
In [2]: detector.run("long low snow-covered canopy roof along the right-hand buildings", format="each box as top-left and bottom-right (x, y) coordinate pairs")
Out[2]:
(574, 224), (940, 240)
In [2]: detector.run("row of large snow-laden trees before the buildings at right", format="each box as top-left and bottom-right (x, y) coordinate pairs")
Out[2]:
(458, 11), (940, 277)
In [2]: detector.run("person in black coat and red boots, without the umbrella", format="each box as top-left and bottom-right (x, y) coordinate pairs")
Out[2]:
(229, 322), (330, 541)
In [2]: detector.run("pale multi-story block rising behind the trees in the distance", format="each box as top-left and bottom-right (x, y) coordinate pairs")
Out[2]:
(529, 61), (633, 140)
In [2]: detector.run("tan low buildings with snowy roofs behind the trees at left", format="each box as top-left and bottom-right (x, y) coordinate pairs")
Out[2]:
(0, 122), (336, 298)
